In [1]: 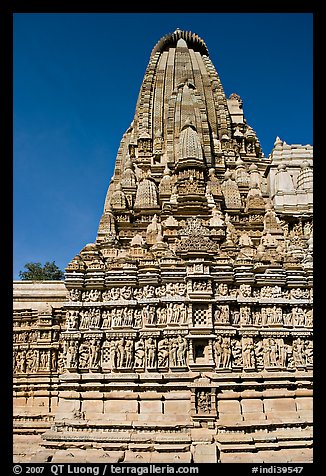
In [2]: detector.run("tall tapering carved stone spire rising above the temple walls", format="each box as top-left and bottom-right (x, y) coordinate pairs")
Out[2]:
(97, 29), (267, 249)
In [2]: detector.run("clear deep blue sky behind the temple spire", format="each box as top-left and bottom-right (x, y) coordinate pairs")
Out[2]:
(13, 13), (313, 279)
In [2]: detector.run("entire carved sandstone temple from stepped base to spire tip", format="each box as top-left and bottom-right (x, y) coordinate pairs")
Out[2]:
(14, 29), (312, 463)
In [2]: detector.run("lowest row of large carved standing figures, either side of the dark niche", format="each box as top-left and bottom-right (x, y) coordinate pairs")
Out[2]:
(56, 334), (313, 372)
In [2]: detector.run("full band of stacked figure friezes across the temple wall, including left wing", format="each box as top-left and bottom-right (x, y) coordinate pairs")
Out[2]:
(13, 278), (313, 375)
